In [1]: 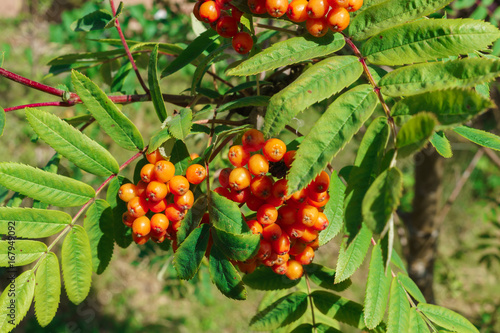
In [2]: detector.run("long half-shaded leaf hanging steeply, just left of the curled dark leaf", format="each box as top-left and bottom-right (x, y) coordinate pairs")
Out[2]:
(344, 117), (390, 236)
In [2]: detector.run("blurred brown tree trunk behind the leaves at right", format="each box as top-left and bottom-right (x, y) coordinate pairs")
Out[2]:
(405, 145), (443, 303)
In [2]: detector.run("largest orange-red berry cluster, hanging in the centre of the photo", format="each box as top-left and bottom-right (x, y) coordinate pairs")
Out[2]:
(214, 129), (330, 280)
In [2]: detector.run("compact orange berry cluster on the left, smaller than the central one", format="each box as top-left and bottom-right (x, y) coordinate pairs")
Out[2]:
(118, 150), (207, 245)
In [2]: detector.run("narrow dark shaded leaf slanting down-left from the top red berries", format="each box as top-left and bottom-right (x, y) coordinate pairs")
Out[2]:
(161, 29), (219, 78)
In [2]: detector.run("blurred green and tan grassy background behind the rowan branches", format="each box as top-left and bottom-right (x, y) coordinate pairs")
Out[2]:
(0, 0), (500, 333)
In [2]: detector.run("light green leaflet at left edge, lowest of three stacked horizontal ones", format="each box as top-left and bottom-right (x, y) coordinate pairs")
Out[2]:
(0, 238), (47, 267)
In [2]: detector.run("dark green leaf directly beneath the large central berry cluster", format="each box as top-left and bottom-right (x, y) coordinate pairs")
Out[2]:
(243, 265), (300, 290)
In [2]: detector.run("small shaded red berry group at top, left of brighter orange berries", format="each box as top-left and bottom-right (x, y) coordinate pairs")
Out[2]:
(193, 0), (253, 54)
